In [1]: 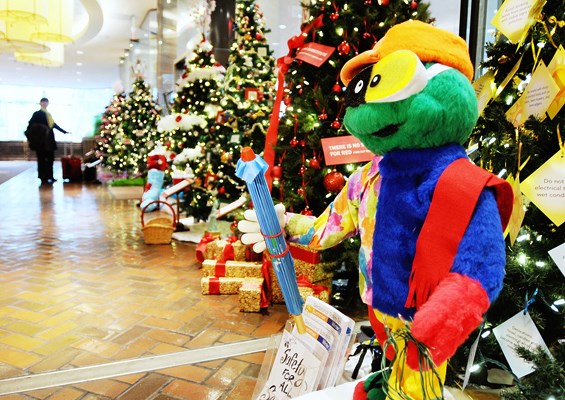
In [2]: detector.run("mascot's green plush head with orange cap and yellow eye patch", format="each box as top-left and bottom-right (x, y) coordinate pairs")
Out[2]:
(341, 21), (478, 154)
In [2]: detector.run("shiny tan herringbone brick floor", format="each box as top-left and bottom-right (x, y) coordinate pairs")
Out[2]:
(0, 164), (294, 400)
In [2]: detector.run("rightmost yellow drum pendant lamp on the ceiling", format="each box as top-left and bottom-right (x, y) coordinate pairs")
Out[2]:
(31, 0), (74, 43)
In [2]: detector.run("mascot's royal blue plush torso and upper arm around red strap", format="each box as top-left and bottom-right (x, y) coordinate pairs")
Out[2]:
(372, 144), (506, 318)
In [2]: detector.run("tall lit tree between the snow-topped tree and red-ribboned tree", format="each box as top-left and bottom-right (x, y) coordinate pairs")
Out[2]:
(200, 0), (275, 209)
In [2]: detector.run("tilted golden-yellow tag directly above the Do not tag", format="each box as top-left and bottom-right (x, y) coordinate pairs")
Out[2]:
(506, 61), (559, 127)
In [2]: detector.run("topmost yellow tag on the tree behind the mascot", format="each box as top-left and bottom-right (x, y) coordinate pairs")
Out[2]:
(491, 0), (545, 43)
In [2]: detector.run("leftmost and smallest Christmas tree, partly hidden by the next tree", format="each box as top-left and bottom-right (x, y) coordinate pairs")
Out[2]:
(95, 93), (126, 173)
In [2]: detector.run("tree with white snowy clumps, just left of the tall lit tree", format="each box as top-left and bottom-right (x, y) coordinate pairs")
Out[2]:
(158, 38), (225, 220)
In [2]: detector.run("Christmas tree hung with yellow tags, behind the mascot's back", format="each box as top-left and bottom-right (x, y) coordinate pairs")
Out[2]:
(451, 0), (565, 399)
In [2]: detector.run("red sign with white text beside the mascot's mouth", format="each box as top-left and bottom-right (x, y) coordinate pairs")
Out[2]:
(322, 135), (375, 165)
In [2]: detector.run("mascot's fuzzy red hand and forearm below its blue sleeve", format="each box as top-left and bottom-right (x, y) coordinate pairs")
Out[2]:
(406, 273), (490, 370)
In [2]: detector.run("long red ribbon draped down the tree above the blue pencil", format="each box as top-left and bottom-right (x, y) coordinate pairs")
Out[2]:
(263, 14), (324, 190)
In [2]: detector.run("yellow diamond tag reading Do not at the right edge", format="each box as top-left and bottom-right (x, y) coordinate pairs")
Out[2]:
(521, 150), (565, 226)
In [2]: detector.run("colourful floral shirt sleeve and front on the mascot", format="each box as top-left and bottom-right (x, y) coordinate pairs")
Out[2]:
(286, 156), (381, 305)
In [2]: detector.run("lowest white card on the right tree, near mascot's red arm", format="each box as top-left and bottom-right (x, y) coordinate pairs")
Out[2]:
(492, 311), (551, 378)
